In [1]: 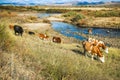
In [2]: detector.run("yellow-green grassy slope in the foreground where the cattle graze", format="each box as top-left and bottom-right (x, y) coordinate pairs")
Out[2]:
(0, 6), (120, 80)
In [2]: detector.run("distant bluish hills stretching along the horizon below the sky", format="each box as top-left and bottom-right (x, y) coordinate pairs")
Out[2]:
(0, 1), (120, 6)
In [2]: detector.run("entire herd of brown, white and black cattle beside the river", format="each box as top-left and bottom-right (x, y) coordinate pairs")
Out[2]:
(9, 25), (108, 62)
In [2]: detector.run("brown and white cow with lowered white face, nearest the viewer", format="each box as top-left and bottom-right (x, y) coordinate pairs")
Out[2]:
(82, 41), (105, 63)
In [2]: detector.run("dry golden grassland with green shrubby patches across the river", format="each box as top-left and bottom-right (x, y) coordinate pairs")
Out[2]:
(63, 8), (120, 28)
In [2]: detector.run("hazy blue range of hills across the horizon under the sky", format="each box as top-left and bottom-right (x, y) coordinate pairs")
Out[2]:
(0, 1), (120, 6)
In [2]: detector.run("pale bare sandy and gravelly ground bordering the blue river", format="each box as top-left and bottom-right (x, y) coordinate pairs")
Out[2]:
(16, 10), (120, 48)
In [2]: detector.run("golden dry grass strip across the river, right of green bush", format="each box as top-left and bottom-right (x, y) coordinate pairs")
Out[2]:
(87, 17), (120, 28)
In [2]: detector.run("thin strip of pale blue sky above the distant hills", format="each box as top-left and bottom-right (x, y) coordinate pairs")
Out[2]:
(0, 0), (120, 3)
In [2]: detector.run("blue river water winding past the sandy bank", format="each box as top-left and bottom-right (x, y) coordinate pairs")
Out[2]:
(38, 13), (120, 40)
